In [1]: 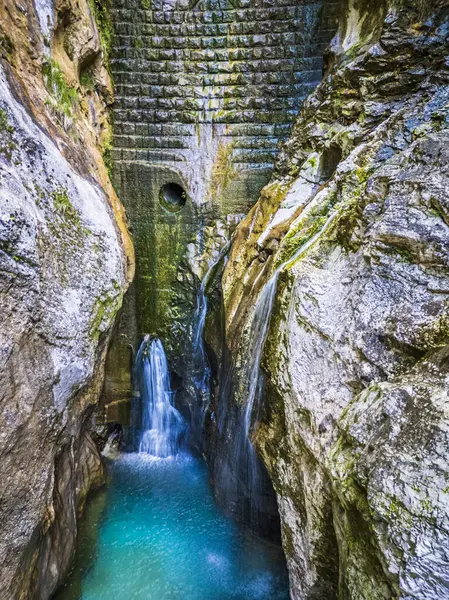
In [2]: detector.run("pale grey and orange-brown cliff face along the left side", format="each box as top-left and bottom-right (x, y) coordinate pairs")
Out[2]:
(0, 2), (133, 600)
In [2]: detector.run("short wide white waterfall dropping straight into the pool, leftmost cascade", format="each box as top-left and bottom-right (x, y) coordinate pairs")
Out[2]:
(133, 335), (185, 458)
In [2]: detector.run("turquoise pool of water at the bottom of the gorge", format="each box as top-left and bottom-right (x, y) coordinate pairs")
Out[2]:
(56, 454), (289, 600)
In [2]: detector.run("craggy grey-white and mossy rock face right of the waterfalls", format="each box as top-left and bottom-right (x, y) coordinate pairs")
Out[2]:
(218, 0), (449, 600)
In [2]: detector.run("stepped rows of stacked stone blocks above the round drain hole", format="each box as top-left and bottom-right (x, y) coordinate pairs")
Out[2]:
(111, 0), (338, 183)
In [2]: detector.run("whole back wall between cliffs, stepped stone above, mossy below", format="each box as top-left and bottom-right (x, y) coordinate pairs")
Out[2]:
(102, 0), (338, 422)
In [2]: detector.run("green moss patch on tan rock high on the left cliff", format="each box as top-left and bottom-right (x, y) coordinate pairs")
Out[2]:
(42, 58), (80, 131)
